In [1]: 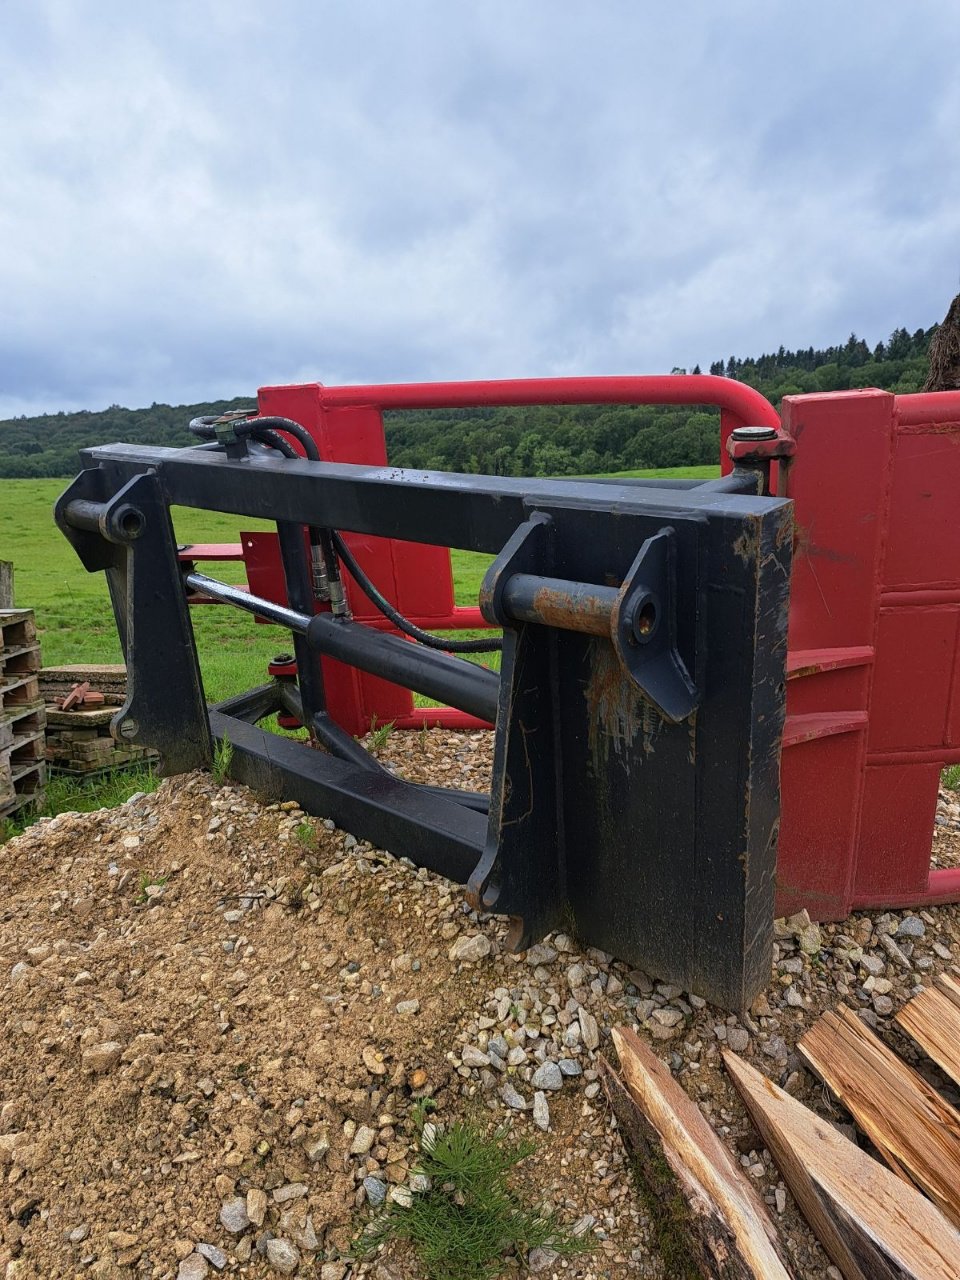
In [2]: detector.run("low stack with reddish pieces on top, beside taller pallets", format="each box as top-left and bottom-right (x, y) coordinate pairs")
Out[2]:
(40, 663), (156, 776)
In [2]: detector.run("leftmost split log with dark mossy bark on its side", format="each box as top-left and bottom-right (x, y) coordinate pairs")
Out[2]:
(602, 1027), (795, 1280)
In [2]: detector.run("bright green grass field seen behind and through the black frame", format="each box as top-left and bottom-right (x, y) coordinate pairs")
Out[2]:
(0, 467), (718, 701)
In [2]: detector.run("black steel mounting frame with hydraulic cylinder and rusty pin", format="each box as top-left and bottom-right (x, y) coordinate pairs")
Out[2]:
(56, 433), (792, 1009)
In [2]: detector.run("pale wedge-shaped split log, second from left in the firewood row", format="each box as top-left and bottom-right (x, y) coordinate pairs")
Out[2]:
(723, 1050), (960, 1280)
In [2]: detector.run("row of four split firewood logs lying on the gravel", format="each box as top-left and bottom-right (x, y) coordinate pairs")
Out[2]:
(602, 974), (960, 1280)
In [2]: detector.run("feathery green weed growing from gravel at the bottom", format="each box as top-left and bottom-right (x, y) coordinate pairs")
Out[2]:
(353, 1108), (590, 1280)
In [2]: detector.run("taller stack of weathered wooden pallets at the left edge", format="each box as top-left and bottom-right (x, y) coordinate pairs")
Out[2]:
(0, 609), (46, 818)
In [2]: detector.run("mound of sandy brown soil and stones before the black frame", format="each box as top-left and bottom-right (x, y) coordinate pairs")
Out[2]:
(0, 776), (643, 1280)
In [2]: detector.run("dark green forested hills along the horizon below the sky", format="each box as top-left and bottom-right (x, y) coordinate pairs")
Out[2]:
(0, 325), (938, 477)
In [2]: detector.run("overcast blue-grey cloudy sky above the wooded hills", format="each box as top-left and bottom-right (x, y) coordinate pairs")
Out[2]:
(0, 0), (960, 417)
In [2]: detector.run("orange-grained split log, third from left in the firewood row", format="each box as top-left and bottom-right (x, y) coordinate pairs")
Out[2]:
(796, 1007), (960, 1228)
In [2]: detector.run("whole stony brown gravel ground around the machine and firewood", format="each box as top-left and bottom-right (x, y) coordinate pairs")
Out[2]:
(0, 731), (960, 1280)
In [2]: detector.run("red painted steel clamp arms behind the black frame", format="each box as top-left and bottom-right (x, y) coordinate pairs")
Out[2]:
(184, 375), (960, 919)
